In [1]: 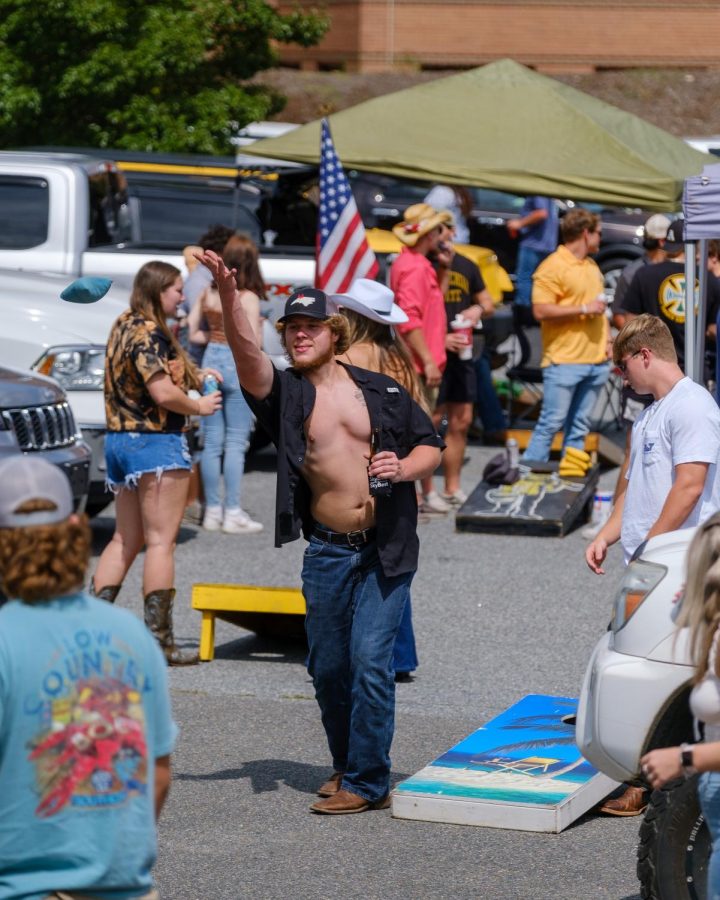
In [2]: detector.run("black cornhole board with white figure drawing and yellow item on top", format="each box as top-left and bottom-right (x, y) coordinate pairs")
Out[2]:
(455, 462), (600, 537)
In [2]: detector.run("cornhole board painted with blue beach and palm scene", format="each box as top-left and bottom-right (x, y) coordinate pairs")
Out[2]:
(392, 694), (618, 834)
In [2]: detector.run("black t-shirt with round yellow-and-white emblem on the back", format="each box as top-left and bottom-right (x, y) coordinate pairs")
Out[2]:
(622, 261), (720, 367)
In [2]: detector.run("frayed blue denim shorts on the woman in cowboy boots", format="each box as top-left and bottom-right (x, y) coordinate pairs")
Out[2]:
(105, 431), (192, 493)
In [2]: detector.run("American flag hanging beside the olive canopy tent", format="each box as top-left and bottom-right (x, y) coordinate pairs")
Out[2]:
(315, 119), (378, 294)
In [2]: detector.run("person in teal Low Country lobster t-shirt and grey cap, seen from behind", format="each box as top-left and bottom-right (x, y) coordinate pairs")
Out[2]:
(0, 456), (177, 900)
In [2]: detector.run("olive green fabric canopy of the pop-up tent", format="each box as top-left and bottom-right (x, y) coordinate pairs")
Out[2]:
(252, 59), (710, 210)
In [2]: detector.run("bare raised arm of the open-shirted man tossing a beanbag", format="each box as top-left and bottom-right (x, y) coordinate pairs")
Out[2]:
(195, 250), (273, 400)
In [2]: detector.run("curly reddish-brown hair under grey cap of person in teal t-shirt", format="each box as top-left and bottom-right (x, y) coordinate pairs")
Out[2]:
(0, 500), (92, 603)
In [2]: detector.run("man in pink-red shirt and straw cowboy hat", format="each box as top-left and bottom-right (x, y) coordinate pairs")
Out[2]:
(390, 203), (452, 513)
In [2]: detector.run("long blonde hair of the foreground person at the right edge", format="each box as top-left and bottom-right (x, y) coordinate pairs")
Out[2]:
(675, 513), (720, 683)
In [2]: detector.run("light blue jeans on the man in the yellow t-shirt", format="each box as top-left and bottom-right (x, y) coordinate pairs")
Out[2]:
(524, 363), (610, 462)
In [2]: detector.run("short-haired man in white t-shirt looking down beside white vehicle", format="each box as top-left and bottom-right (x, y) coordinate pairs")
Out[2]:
(585, 314), (720, 575)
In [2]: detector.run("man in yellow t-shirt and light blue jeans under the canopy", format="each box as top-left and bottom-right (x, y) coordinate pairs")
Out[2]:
(525, 209), (610, 461)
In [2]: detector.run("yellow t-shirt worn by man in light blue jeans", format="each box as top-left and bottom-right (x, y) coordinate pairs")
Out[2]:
(532, 244), (609, 367)
